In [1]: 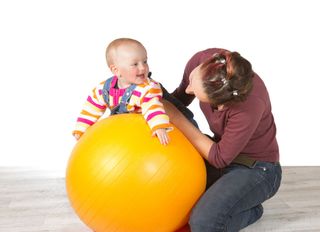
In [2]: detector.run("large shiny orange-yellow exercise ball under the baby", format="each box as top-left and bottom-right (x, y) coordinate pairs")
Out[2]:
(66, 114), (206, 232)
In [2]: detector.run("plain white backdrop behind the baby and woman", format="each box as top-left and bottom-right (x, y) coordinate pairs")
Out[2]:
(0, 0), (320, 170)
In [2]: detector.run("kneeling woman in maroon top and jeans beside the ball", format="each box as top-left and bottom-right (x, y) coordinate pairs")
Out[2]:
(164, 48), (281, 232)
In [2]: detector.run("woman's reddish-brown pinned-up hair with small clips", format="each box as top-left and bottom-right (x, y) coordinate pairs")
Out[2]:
(201, 51), (254, 106)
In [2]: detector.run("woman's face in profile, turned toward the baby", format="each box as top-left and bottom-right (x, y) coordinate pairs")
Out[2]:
(185, 64), (210, 102)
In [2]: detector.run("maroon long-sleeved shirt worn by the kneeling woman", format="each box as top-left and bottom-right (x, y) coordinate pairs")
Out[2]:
(172, 48), (279, 168)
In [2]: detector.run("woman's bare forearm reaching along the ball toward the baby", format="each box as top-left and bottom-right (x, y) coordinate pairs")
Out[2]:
(162, 100), (214, 160)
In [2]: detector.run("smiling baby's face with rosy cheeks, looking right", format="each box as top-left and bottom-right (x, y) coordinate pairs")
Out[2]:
(115, 43), (149, 87)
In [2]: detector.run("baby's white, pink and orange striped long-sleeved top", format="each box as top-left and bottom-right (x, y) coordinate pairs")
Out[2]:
(72, 76), (173, 135)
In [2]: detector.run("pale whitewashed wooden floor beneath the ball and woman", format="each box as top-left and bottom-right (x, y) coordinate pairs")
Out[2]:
(0, 166), (320, 232)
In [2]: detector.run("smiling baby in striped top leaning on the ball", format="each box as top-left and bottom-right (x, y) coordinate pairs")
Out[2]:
(72, 38), (173, 145)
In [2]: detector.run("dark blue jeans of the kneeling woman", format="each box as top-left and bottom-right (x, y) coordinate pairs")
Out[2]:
(189, 161), (282, 232)
